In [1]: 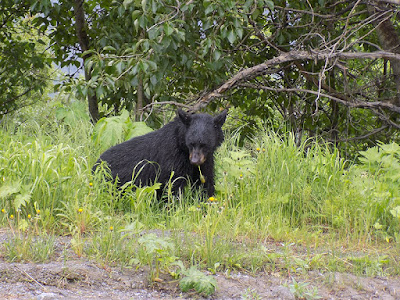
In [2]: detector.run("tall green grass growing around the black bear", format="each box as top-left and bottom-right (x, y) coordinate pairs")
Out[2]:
(0, 103), (400, 269)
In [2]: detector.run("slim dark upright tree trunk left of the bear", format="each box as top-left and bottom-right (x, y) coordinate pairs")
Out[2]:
(74, 0), (99, 123)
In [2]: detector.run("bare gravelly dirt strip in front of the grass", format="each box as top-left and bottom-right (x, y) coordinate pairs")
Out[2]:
(0, 233), (400, 300)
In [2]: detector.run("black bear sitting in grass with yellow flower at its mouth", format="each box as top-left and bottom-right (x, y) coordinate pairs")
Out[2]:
(93, 109), (227, 196)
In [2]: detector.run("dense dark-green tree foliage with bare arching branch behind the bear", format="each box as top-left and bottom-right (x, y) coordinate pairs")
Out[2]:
(1, 0), (400, 155)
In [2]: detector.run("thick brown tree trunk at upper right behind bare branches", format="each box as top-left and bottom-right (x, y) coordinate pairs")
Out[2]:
(368, 3), (400, 106)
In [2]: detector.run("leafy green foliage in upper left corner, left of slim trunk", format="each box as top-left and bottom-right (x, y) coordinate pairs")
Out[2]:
(0, 0), (51, 118)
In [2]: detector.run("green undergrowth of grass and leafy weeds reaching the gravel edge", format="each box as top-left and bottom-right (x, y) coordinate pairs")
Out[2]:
(0, 100), (400, 294)
